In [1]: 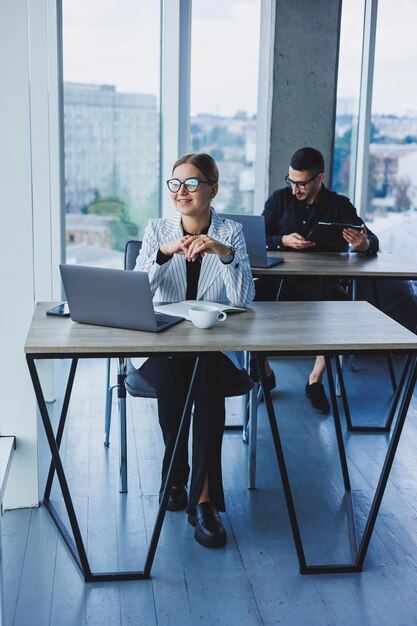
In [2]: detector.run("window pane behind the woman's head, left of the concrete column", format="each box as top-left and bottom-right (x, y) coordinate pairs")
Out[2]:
(191, 0), (260, 213)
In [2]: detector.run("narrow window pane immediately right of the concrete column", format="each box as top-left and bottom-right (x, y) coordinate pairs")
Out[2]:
(332, 0), (365, 199)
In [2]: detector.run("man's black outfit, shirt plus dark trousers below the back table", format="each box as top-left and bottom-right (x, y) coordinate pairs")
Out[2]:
(255, 185), (378, 300)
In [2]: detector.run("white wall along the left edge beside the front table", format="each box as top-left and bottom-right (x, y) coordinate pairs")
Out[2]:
(0, 0), (60, 508)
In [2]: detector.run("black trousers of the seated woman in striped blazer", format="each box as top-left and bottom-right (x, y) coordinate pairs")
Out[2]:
(140, 352), (239, 514)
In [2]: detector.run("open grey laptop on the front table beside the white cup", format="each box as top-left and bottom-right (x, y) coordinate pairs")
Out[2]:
(59, 265), (184, 333)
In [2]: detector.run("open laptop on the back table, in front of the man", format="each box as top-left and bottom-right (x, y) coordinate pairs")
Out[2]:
(220, 213), (284, 267)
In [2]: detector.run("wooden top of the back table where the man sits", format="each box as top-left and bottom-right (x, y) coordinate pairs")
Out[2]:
(252, 251), (417, 280)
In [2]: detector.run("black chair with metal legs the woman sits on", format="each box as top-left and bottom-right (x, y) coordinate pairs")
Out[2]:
(104, 240), (257, 493)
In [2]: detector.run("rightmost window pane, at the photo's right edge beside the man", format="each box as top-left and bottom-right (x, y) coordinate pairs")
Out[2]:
(366, 0), (417, 256)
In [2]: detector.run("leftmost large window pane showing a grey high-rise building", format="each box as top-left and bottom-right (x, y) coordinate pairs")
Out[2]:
(63, 0), (160, 267)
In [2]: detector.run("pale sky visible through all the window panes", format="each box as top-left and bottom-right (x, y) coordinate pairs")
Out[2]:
(63, 0), (417, 115)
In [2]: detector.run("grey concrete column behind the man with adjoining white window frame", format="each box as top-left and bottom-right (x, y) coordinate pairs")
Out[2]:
(255, 0), (342, 207)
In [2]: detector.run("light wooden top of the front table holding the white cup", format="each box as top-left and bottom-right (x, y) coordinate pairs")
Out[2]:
(25, 301), (417, 358)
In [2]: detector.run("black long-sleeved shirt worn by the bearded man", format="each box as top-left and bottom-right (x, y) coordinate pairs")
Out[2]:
(263, 185), (378, 255)
